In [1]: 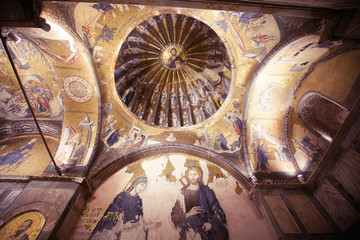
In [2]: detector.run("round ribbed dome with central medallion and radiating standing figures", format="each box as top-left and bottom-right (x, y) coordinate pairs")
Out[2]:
(115, 14), (232, 127)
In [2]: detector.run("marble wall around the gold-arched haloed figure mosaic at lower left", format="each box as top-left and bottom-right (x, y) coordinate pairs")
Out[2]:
(0, 180), (81, 239)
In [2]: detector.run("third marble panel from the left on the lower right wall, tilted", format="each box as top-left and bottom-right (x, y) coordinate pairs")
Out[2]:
(314, 180), (360, 231)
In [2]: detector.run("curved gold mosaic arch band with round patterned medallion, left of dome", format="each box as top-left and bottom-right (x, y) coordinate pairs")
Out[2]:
(16, 12), (101, 172)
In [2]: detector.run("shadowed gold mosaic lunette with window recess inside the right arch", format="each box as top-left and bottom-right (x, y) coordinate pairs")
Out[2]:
(285, 47), (360, 179)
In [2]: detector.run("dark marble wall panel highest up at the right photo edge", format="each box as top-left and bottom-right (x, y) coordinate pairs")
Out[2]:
(332, 148), (360, 201)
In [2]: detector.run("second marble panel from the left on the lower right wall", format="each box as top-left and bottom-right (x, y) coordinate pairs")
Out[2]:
(287, 194), (332, 233)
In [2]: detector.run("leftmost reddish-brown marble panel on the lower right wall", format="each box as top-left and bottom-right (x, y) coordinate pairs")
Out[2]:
(264, 196), (301, 233)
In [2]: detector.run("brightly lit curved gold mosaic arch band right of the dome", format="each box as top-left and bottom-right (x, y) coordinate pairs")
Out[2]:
(244, 35), (334, 182)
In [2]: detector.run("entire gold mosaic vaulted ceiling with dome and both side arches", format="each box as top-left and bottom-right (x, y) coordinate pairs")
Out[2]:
(0, 2), (360, 188)
